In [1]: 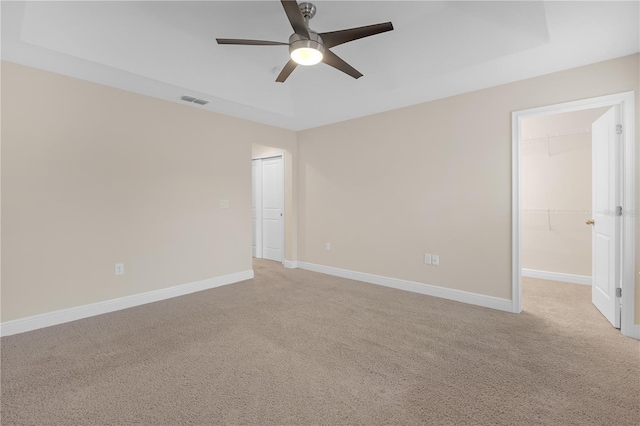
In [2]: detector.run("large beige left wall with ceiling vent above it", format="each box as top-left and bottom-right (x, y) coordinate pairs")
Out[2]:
(2, 62), (296, 321)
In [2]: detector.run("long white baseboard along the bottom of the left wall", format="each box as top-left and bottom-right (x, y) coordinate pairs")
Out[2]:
(0, 270), (253, 336)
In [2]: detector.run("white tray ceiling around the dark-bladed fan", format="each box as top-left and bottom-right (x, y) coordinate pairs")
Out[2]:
(2, 0), (640, 130)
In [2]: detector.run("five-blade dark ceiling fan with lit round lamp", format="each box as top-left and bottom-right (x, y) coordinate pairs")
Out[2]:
(216, 0), (393, 83)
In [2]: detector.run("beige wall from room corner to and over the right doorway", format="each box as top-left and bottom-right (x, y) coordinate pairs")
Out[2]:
(298, 55), (640, 322)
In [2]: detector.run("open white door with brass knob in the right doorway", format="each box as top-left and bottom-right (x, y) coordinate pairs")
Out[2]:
(591, 107), (620, 328)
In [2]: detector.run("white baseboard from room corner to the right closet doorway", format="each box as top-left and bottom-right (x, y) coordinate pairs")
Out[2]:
(298, 262), (512, 312)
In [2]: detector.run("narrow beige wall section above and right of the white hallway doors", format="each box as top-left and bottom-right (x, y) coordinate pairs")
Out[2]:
(251, 144), (298, 261)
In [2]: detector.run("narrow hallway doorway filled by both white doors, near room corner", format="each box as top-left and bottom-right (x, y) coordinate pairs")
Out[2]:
(251, 155), (284, 262)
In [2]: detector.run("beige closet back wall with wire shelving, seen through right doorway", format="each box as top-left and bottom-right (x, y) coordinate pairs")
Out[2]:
(520, 108), (608, 276)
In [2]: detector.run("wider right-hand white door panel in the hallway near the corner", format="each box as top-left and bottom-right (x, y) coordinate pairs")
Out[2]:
(262, 157), (284, 262)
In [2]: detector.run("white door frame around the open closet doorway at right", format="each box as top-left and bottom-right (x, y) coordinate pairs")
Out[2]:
(511, 91), (640, 339)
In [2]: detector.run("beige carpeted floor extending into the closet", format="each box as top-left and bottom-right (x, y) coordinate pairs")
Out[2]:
(1, 261), (640, 426)
